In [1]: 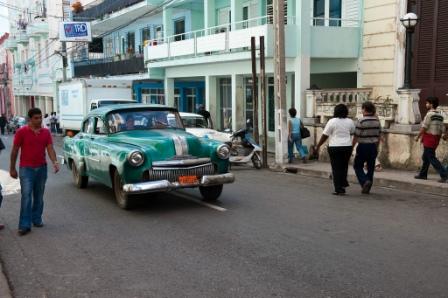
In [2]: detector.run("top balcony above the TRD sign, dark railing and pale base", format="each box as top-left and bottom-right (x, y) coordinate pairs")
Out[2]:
(73, 0), (162, 36)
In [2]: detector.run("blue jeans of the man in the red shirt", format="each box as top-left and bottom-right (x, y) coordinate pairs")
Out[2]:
(19, 165), (47, 230)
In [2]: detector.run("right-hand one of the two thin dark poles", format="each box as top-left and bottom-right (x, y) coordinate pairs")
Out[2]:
(260, 36), (268, 168)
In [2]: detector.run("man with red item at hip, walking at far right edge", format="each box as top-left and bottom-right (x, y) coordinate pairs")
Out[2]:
(415, 96), (448, 183)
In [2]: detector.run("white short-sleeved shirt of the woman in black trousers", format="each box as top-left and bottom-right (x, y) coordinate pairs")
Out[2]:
(323, 118), (355, 147)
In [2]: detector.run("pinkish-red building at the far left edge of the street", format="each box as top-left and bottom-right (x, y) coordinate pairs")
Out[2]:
(0, 33), (15, 118)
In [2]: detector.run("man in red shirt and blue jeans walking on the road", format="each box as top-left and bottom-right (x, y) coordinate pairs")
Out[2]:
(9, 108), (59, 236)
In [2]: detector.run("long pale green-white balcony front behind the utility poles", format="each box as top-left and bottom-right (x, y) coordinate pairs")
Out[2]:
(145, 16), (361, 67)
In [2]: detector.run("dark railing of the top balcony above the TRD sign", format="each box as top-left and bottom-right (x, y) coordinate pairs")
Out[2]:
(73, 0), (146, 21)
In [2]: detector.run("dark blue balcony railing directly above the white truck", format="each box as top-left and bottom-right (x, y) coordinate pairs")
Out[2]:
(73, 55), (146, 77)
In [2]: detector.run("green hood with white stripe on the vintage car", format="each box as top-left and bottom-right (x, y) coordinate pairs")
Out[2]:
(108, 129), (210, 161)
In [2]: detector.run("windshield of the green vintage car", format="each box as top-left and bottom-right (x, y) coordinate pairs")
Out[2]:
(107, 110), (184, 133)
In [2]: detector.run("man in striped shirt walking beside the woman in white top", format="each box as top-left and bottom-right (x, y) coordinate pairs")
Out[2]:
(353, 101), (381, 194)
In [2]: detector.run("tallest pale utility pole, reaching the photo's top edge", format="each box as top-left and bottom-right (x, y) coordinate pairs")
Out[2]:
(273, 0), (288, 166)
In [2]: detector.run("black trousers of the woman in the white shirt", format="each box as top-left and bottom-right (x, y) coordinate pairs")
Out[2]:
(328, 146), (353, 193)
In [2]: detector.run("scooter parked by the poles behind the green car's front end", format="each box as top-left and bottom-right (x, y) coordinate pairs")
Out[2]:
(228, 128), (263, 169)
